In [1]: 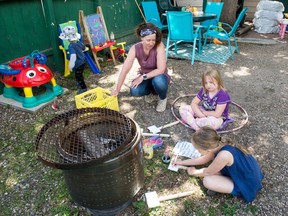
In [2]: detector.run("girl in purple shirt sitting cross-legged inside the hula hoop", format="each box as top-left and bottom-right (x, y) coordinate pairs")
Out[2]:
(179, 70), (231, 130)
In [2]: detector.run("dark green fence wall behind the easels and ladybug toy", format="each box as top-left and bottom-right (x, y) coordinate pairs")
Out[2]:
(0, 0), (143, 72)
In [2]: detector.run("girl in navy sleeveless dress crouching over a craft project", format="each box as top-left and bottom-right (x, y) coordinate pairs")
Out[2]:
(172, 126), (263, 202)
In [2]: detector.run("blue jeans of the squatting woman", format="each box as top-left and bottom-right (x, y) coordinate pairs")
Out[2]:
(130, 74), (169, 100)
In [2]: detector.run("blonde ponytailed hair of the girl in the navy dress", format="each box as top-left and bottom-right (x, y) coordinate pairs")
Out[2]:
(192, 126), (250, 155)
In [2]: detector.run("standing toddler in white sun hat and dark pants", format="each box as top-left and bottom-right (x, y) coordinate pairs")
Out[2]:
(59, 26), (87, 94)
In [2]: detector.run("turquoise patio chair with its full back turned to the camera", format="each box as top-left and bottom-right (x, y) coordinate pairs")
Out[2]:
(166, 11), (202, 65)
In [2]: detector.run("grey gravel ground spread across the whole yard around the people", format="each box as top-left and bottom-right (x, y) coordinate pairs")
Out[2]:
(0, 30), (288, 216)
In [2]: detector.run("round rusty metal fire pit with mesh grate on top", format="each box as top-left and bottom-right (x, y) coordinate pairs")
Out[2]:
(36, 108), (144, 215)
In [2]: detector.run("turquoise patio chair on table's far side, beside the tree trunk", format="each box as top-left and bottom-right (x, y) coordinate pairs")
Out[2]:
(200, 2), (224, 29)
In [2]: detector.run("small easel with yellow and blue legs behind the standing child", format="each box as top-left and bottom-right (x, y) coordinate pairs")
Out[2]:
(58, 21), (100, 77)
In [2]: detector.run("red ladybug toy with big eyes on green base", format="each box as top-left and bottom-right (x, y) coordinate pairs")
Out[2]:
(0, 51), (64, 108)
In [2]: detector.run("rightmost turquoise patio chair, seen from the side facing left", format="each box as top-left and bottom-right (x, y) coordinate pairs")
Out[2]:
(203, 8), (248, 60)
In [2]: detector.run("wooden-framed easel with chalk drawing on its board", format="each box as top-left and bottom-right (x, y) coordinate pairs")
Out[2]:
(79, 6), (116, 70)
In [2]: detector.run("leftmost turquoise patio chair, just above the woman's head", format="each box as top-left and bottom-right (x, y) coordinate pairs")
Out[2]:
(141, 1), (168, 30)
